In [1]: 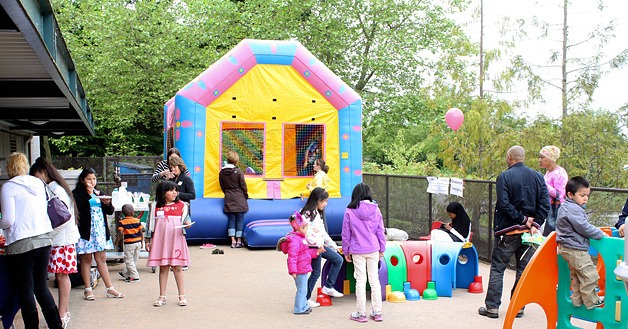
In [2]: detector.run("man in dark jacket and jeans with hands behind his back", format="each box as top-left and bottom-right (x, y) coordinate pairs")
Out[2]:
(478, 145), (549, 319)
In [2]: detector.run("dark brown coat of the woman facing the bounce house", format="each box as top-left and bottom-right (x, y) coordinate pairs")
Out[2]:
(218, 163), (249, 212)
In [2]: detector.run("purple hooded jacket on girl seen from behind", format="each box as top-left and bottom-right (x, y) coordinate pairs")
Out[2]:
(342, 201), (386, 255)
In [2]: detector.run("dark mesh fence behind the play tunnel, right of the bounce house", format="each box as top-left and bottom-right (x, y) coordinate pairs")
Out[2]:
(363, 174), (628, 261)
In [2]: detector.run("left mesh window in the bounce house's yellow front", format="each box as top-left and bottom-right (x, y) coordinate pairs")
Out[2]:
(222, 122), (264, 175)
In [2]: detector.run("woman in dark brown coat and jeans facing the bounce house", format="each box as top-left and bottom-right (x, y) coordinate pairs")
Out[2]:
(218, 151), (249, 248)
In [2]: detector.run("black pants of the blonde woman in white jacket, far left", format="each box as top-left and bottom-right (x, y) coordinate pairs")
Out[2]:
(7, 246), (61, 329)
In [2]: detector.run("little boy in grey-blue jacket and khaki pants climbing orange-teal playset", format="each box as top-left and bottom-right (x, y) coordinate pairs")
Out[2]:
(556, 176), (606, 310)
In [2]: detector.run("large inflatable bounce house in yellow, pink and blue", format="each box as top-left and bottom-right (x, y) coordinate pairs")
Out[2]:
(164, 40), (362, 247)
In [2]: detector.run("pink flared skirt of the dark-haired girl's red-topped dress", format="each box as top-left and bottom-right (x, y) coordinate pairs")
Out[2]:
(146, 217), (190, 266)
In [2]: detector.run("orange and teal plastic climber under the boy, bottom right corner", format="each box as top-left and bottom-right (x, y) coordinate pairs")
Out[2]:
(504, 232), (628, 329)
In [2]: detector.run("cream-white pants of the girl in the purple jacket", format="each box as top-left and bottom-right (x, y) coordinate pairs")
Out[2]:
(351, 251), (382, 314)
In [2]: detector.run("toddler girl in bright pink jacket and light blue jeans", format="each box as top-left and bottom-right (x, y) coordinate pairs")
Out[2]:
(284, 212), (318, 314)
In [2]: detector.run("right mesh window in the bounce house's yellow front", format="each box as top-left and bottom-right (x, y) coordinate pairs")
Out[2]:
(283, 123), (325, 176)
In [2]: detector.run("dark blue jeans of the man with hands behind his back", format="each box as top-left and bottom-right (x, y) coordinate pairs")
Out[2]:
(484, 234), (534, 309)
